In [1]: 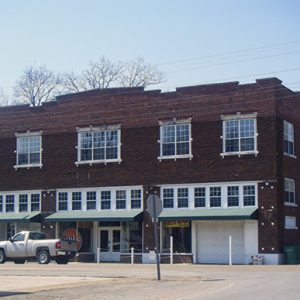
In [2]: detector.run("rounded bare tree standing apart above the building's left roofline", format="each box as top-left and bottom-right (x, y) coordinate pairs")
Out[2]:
(14, 65), (61, 106)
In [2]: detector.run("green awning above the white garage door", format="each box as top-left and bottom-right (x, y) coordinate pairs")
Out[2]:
(158, 207), (257, 221)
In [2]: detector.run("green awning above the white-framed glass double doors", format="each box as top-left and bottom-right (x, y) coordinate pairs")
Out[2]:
(46, 210), (142, 222)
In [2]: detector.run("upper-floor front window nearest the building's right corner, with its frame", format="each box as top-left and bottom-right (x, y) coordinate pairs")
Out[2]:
(221, 113), (258, 156)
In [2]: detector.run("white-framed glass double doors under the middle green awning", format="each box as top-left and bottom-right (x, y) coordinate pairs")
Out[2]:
(100, 227), (121, 261)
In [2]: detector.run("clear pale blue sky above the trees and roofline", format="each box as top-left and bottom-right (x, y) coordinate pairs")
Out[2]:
(0, 0), (300, 95)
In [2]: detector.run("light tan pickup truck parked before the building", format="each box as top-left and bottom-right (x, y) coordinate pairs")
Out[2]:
(0, 231), (77, 264)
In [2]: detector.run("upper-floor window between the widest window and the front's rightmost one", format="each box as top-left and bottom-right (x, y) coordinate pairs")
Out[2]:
(160, 124), (191, 158)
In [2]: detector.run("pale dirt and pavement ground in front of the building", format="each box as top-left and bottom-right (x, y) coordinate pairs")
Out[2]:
(0, 264), (300, 300)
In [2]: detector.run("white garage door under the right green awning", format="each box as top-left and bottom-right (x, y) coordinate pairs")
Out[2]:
(196, 221), (245, 264)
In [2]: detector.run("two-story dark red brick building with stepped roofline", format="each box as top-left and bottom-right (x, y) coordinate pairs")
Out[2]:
(0, 78), (300, 264)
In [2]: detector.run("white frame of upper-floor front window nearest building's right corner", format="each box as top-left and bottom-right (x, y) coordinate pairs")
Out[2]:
(220, 112), (259, 157)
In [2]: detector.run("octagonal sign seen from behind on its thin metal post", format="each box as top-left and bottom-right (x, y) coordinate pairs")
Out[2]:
(147, 194), (162, 280)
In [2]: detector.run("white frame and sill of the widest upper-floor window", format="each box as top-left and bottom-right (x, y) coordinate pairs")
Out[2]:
(75, 124), (122, 166)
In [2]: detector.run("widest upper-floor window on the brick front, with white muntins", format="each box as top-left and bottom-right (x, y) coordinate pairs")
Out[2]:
(78, 130), (120, 163)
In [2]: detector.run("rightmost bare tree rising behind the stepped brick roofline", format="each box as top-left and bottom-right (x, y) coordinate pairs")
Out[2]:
(119, 57), (166, 87)
